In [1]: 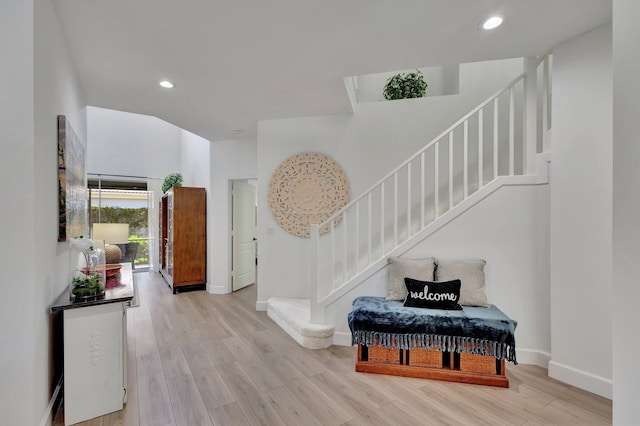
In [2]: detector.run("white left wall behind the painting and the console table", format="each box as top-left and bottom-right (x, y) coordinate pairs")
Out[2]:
(34, 0), (87, 422)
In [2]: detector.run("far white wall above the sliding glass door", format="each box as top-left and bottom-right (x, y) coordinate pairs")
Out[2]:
(87, 107), (182, 179)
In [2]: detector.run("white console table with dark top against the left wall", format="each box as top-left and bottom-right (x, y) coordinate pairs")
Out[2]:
(51, 263), (134, 425)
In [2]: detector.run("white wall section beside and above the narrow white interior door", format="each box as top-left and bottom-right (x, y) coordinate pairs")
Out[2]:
(208, 139), (263, 294)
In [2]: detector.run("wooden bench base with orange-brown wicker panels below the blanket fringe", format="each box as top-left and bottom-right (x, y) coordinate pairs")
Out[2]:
(356, 345), (509, 388)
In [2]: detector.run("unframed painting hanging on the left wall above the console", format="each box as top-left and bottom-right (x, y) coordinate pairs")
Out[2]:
(58, 115), (89, 241)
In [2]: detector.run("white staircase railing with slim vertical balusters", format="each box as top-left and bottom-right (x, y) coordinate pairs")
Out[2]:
(309, 56), (550, 323)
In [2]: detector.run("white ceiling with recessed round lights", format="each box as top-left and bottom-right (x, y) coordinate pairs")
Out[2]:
(54, 0), (612, 140)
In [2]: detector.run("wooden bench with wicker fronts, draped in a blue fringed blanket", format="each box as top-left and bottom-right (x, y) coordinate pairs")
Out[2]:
(349, 297), (517, 387)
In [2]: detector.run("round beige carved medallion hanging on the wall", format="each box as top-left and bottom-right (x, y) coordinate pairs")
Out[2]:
(269, 152), (349, 238)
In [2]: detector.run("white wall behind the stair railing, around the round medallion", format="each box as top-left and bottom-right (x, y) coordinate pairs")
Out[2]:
(257, 59), (523, 308)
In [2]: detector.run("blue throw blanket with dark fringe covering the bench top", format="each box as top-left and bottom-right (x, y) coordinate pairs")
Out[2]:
(348, 296), (517, 364)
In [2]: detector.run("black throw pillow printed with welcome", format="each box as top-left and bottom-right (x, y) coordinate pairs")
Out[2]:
(404, 278), (462, 311)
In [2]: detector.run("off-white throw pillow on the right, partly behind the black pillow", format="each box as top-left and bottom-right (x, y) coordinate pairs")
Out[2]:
(436, 259), (489, 306)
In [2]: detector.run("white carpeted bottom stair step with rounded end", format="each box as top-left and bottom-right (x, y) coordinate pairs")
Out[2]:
(267, 297), (334, 349)
